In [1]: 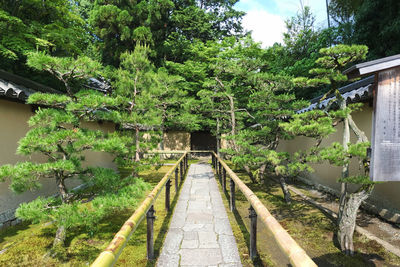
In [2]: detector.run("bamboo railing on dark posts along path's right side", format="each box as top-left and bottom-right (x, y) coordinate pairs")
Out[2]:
(211, 152), (317, 267)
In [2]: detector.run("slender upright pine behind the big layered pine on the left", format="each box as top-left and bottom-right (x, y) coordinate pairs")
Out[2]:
(112, 44), (162, 176)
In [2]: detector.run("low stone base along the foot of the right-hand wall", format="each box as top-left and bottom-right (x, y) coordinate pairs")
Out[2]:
(297, 176), (400, 223)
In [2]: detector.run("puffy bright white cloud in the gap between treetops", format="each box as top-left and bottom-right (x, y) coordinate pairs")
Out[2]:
(243, 10), (286, 47)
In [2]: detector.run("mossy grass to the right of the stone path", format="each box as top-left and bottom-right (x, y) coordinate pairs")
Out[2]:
(216, 162), (400, 267)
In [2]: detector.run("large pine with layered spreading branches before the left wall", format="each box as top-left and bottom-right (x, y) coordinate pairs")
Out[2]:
(0, 53), (147, 253)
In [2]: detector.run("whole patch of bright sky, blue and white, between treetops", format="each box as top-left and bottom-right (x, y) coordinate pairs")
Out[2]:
(235, 0), (327, 47)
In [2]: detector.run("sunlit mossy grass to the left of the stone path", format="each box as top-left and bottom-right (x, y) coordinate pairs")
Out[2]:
(0, 162), (187, 266)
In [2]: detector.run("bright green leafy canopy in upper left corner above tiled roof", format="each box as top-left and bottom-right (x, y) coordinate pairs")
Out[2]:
(0, 0), (90, 66)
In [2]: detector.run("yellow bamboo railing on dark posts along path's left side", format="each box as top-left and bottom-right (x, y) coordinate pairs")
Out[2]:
(91, 151), (188, 267)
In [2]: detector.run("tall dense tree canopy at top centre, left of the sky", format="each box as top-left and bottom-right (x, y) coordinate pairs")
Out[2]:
(89, 0), (243, 66)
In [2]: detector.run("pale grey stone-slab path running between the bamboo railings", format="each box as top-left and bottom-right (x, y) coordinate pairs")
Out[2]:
(157, 163), (242, 267)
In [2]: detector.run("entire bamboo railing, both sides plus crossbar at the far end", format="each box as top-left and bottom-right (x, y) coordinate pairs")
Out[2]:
(91, 150), (317, 267)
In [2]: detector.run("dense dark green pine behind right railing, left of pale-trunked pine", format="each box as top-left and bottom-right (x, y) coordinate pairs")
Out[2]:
(225, 73), (310, 203)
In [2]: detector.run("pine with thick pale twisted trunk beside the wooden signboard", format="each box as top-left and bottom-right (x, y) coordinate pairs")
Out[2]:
(292, 45), (374, 255)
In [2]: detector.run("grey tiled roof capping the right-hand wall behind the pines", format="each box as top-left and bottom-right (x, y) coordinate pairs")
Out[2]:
(297, 76), (374, 113)
